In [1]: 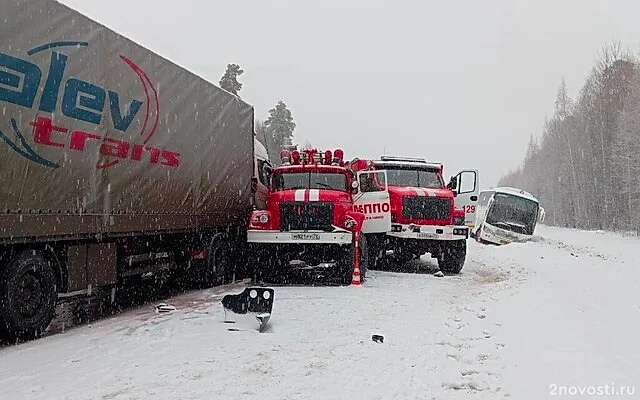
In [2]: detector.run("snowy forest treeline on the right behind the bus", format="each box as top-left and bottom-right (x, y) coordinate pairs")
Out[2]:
(499, 44), (640, 233)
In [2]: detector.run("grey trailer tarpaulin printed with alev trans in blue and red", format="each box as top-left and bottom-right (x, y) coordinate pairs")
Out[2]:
(0, 0), (254, 240)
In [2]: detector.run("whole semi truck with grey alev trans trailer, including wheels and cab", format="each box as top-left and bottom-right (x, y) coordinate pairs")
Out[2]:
(0, 0), (269, 340)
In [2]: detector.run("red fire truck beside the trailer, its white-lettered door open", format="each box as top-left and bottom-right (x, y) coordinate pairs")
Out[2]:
(247, 147), (391, 284)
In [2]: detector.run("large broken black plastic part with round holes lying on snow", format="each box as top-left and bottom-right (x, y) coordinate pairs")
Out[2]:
(222, 287), (274, 332)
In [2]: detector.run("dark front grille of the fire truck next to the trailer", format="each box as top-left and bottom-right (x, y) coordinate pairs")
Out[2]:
(280, 201), (333, 232)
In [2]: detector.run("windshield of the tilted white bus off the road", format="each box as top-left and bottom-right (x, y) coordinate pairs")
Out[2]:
(486, 193), (538, 235)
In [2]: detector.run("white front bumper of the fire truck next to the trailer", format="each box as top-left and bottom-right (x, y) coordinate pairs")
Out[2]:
(247, 230), (352, 244)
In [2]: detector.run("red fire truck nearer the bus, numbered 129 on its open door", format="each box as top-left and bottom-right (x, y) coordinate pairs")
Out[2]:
(347, 156), (479, 273)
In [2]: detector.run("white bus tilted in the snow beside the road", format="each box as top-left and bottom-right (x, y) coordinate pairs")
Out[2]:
(471, 187), (544, 245)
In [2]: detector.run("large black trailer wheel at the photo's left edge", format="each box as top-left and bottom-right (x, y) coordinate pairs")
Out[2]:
(0, 251), (58, 341)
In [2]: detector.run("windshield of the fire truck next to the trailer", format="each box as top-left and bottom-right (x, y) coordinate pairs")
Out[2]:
(273, 171), (348, 191)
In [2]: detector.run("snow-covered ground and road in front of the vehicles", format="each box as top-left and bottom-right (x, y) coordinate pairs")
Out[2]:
(0, 226), (640, 400)
